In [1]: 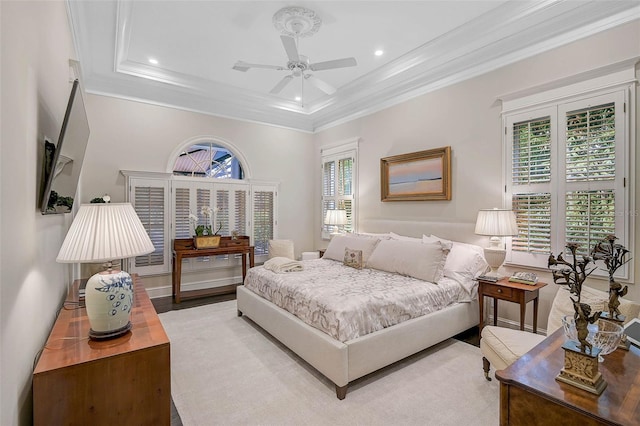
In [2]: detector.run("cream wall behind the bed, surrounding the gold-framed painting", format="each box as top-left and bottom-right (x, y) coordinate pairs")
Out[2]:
(315, 21), (640, 327)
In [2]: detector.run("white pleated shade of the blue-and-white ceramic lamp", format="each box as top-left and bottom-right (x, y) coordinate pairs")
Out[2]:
(56, 203), (154, 263)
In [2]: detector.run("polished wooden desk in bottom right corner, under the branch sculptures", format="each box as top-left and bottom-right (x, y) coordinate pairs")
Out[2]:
(496, 329), (640, 426)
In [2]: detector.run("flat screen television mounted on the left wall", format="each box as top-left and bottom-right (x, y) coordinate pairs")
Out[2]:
(40, 80), (89, 214)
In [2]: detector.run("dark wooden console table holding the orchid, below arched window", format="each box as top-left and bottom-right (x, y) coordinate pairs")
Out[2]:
(171, 236), (255, 303)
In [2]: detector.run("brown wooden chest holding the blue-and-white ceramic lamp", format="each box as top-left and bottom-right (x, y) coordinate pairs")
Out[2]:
(33, 275), (171, 426)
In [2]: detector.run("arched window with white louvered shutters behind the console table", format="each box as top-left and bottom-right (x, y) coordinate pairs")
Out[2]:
(122, 143), (277, 275)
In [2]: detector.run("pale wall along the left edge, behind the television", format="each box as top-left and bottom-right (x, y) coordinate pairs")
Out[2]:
(0, 1), (75, 425)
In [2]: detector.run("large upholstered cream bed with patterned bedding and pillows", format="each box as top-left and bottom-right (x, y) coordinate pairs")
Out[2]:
(237, 221), (487, 399)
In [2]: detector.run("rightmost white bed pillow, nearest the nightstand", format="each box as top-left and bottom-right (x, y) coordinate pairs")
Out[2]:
(422, 235), (489, 298)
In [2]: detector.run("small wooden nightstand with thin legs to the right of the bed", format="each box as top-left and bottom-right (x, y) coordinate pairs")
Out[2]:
(478, 277), (547, 333)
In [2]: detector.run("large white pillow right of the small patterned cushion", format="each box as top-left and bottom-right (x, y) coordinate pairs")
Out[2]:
(367, 240), (448, 284)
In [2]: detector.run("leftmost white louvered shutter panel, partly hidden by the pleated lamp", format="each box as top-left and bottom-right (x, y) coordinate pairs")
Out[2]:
(127, 179), (171, 275)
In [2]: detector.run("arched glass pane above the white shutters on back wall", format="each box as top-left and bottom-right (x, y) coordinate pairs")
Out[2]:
(173, 142), (244, 179)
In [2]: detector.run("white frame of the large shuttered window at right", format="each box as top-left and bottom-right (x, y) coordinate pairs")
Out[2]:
(502, 68), (636, 280)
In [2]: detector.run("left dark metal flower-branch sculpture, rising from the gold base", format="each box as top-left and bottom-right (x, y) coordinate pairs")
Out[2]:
(548, 243), (601, 353)
